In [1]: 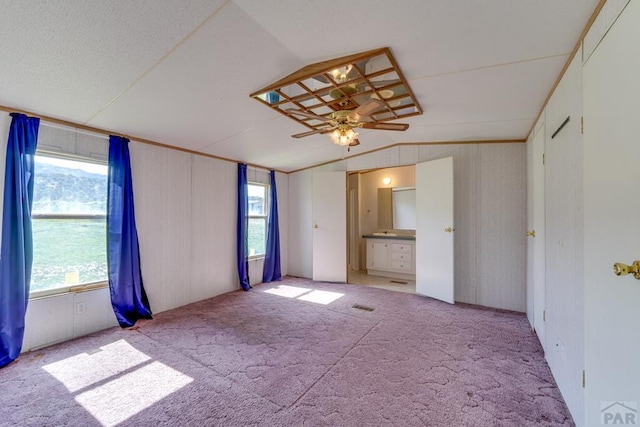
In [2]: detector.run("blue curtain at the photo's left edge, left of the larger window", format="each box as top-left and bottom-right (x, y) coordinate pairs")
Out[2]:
(0, 113), (40, 368)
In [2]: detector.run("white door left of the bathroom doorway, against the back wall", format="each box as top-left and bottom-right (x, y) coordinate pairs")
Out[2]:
(312, 172), (347, 283)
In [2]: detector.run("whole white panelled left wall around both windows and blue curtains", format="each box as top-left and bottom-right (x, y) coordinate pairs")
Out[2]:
(0, 113), (289, 351)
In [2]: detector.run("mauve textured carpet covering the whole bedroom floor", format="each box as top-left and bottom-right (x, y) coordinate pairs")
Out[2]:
(0, 277), (573, 426)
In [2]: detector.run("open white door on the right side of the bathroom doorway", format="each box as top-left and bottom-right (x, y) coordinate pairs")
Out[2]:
(416, 157), (455, 304)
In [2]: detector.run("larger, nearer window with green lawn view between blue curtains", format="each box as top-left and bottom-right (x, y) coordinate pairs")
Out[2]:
(31, 153), (107, 295)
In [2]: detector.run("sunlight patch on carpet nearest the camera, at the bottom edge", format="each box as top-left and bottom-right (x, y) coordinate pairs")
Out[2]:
(75, 361), (193, 425)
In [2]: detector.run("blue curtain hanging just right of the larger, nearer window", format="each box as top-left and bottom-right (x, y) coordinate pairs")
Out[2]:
(107, 135), (152, 328)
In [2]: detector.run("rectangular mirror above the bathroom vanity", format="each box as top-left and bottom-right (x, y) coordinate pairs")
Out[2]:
(378, 187), (416, 230)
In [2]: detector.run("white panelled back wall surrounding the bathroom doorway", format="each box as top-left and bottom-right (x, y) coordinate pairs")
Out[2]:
(289, 144), (526, 311)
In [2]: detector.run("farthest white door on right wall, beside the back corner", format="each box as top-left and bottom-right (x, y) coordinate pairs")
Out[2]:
(527, 123), (547, 351)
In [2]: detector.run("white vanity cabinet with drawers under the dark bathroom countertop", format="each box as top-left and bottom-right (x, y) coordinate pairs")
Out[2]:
(365, 236), (416, 280)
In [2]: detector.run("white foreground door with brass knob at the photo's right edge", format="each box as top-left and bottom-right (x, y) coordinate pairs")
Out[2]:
(583, 1), (640, 426)
